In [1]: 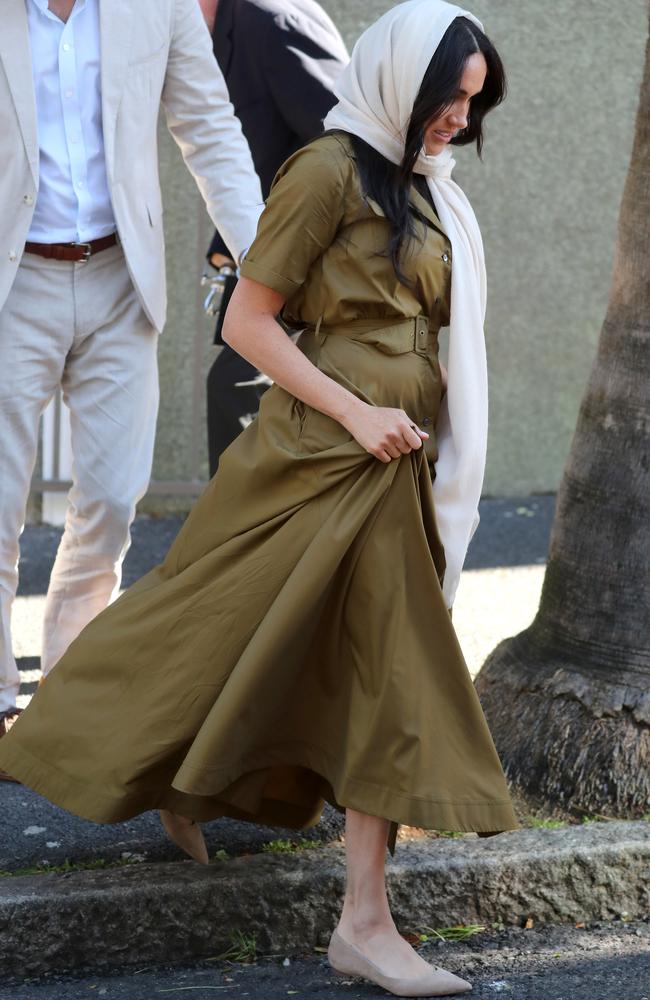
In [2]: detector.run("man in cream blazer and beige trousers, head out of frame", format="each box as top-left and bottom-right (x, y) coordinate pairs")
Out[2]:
(0, 0), (262, 772)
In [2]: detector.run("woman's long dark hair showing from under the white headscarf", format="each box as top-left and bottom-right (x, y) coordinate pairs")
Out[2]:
(351, 17), (506, 284)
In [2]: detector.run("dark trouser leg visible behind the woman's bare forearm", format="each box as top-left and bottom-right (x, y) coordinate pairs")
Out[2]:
(207, 344), (267, 476)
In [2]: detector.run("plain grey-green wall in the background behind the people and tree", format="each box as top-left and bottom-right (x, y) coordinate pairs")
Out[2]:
(145, 0), (648, 509)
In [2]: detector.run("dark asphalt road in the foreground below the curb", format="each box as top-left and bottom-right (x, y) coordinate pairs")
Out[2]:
(0, 923), (650, 1000)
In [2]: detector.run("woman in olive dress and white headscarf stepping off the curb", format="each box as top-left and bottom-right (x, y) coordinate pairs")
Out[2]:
(0, 0), (516, 996)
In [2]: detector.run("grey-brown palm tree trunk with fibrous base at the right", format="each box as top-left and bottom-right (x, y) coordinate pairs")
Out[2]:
(477, 31), (650, 816)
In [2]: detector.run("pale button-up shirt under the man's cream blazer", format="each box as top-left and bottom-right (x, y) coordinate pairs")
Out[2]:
(26, 0), (115, 243)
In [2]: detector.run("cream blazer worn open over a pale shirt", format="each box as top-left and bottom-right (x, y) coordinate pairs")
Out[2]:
(0, 0), (263, 330)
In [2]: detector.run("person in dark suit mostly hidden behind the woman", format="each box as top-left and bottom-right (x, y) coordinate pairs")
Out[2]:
(199, 0), (349, 475)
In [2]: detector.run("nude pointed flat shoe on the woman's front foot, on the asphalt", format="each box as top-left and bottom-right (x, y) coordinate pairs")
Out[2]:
(327, 931), (472, 997)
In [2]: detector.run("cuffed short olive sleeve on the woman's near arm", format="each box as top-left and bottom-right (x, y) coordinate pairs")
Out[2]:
(241, 139), (349, 299)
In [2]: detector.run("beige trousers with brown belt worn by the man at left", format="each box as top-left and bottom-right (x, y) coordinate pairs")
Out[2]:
(0, 246), (158, 712)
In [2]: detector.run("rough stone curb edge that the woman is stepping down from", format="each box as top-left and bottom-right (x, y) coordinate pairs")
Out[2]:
(0, 822), (650, 982)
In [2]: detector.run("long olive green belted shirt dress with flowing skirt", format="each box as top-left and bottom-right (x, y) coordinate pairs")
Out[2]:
(0, 134), (516, 832)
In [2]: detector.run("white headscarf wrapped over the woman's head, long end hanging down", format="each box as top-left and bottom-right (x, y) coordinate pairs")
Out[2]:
(325, 0), (488, 607)
